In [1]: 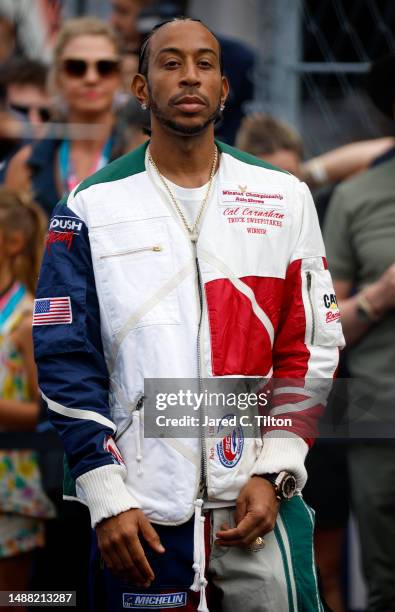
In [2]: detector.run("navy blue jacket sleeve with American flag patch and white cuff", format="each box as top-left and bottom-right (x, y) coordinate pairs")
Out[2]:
(33, 203), (138, 522)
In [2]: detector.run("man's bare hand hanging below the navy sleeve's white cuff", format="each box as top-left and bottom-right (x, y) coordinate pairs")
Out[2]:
(96, 508), (165, 588)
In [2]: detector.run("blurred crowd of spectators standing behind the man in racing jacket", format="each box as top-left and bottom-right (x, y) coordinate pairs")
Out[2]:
(0, 0), (395, 612)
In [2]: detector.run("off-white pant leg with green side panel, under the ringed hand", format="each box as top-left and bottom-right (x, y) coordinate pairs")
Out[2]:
(209, 496), (323, 612)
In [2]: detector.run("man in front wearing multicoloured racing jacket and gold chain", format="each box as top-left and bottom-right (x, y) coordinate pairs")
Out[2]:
(35, 19), (343, 612)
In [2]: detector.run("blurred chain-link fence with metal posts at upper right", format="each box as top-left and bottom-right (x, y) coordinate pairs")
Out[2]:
(255, 0), (395, 155)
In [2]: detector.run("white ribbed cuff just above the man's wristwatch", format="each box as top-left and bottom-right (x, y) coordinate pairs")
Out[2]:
(251, 430), (309, 491)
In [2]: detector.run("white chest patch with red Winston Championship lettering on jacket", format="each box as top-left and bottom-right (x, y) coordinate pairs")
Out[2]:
(219, 183), (285, 208)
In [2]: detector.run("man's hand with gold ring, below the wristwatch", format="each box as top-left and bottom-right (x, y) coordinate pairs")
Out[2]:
(215, 476), (280, 546)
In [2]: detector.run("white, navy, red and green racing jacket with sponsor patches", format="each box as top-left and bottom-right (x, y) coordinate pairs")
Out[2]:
(33, 137), (344, 525)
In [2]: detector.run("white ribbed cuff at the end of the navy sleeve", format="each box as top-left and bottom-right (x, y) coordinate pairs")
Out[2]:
(76, 465), (140, 528)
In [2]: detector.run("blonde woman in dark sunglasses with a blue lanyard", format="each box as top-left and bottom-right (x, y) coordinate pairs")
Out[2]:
(6, 17), (121, 215)
